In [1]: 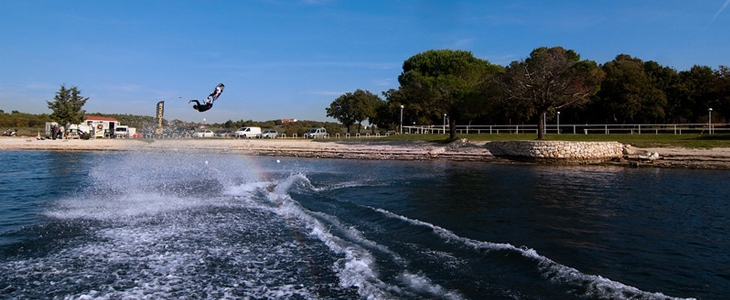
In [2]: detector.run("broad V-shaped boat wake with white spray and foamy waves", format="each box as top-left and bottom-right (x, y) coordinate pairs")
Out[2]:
(0, 154), (692, 299)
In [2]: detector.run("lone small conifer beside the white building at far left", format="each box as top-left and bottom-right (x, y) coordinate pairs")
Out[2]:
(46, 84), (89, 125)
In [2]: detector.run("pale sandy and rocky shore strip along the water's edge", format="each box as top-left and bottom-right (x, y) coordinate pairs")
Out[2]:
(0, 135), (730, 170)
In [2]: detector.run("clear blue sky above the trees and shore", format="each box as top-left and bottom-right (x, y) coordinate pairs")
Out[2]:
(0, 0), (730, 122)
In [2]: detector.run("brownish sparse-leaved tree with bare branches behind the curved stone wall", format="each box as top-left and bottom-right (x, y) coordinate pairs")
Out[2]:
(500, 47), (603, 139)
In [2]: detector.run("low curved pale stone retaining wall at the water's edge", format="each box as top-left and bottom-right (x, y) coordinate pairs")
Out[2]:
(486, 141), (624, 164)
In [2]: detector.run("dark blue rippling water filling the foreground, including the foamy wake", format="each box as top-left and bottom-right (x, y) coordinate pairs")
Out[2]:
(0, 151), (730, 299)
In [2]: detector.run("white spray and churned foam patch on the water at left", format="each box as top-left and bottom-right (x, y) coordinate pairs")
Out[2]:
(0, 156), (338, 299)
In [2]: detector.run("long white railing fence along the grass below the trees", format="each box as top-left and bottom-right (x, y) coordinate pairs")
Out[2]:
(403, 123), (730, 134)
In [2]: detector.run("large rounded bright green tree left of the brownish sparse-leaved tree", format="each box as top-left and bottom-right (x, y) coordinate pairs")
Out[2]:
(398, 50), (501, 140)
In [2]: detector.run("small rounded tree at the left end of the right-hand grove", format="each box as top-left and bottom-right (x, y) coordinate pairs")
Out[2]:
(325, 89), (383, 133)
